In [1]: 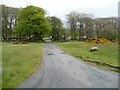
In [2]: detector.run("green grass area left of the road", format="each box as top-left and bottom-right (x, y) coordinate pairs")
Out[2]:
(2, 43), (44, 88)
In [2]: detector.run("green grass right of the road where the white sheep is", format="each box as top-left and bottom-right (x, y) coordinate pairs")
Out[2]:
(55, 42), (119, 72)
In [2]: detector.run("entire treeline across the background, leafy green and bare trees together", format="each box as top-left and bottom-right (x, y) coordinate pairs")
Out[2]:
(0, 5), (120, 41)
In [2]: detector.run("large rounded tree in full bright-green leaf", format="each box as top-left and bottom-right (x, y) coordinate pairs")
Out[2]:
(16, 5), (51, 41)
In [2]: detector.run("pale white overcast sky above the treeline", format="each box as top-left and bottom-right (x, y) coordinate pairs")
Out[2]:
(0, 0), (120, 20)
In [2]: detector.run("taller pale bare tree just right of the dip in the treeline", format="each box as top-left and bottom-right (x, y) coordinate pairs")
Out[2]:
(66, 11), (94, 40)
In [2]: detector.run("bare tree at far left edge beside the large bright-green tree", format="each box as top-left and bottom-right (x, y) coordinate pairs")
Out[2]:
(0, 5), (19, 40)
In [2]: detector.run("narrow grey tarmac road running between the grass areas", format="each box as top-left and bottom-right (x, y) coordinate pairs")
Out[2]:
(18, 44), (118, 88)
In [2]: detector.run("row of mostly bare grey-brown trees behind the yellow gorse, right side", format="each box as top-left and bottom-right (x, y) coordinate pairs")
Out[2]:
(66, 11), (118, 41)
